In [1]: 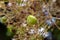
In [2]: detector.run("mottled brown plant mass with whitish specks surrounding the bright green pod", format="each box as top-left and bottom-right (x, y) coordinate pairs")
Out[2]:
(0, 0), (60, 40)
